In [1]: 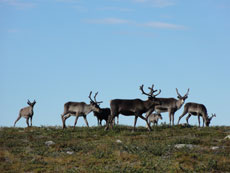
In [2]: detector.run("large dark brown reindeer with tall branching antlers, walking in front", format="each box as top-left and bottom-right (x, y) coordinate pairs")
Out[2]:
(105, 85), (161, 131)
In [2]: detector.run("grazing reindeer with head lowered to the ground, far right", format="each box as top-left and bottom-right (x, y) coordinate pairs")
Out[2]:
(177, 102), (216, 127)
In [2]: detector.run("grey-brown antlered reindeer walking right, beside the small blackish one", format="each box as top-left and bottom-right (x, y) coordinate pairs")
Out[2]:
(61, 91), (100, 129)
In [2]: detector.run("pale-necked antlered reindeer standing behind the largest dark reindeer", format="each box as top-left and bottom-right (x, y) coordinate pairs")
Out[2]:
(154, 88), (189, 125)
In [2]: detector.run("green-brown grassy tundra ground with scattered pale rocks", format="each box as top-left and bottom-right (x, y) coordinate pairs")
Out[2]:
(0, 125), (230, 173)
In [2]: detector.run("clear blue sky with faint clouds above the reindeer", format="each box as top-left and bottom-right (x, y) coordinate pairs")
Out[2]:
(0, 0), (230, 127)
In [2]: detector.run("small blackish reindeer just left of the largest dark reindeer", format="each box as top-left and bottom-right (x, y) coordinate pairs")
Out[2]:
(93, 92), (110, 126)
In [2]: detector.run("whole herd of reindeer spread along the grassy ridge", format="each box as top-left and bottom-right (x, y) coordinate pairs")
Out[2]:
(14, 85), (216, 131)
